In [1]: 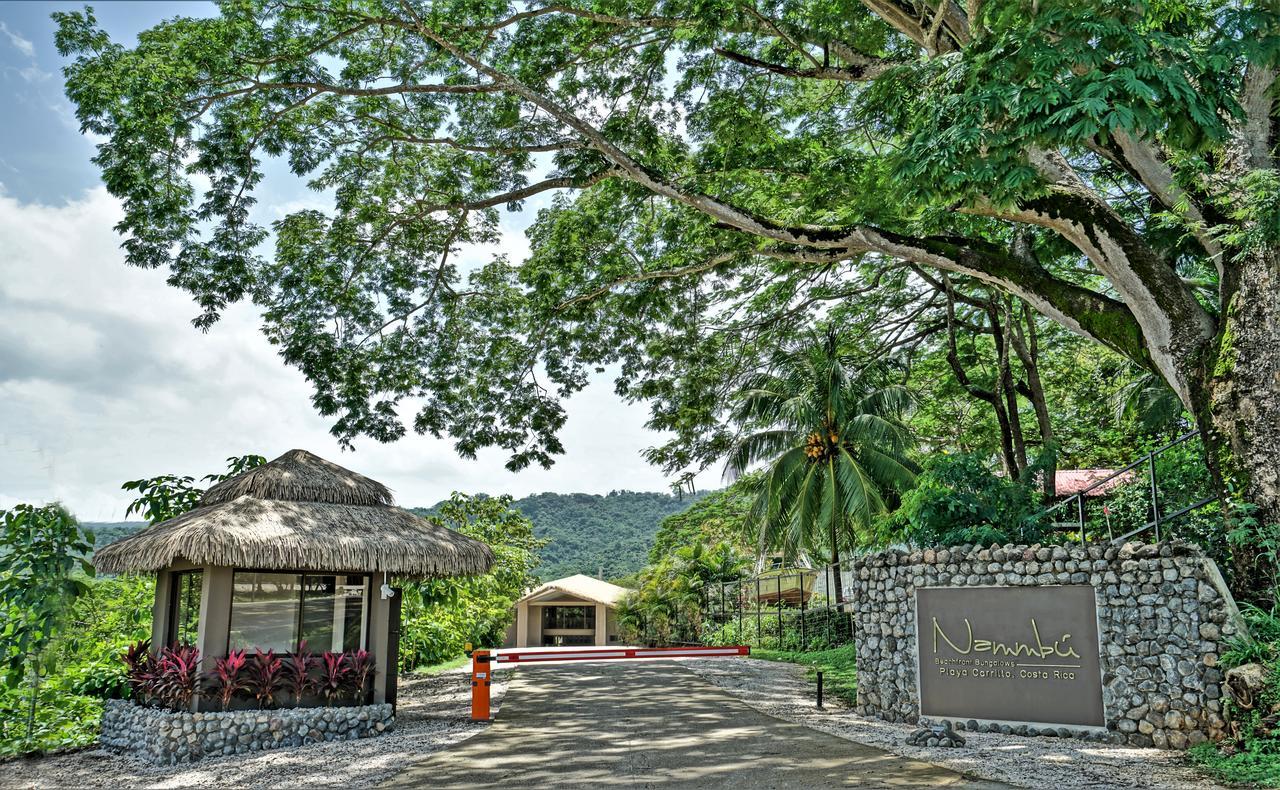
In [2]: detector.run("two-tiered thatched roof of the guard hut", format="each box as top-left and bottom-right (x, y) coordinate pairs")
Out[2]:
(93, 449), (493, 576)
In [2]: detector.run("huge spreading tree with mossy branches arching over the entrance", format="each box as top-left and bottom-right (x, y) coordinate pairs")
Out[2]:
(58, 0), (1280, 530)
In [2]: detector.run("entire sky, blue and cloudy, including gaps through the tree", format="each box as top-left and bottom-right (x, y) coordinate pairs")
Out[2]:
(0, 1), (718, 521)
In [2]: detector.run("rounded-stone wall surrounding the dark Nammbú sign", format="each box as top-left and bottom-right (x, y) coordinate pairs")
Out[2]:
(854, 543), (1243, 749)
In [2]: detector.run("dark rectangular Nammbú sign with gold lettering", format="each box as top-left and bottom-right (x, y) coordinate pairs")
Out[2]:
(915, 585), (1106, 727)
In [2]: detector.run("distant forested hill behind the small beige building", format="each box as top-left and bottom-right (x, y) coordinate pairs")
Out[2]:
(425, 490), (703, 580)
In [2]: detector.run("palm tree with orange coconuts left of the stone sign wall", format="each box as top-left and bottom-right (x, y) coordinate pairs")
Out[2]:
(726, 334), (918, 599)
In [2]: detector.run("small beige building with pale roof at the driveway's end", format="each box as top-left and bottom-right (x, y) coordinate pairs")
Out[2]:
(503, 574), (630, 648)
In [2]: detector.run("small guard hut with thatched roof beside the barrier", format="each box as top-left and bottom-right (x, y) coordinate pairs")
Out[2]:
(93, 449), (493, 709)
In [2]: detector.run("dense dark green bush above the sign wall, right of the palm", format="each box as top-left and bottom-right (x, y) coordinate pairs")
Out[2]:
(881, 453), (1041, 545)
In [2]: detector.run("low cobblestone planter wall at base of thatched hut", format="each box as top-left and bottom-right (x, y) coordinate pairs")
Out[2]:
(101, 699), (394, 764)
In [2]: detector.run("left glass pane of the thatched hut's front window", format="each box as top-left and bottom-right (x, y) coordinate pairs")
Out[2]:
(230, 571), (302, 653)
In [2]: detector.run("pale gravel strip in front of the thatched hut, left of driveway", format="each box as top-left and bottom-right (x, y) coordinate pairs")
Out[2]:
(0, 667), (507, 787)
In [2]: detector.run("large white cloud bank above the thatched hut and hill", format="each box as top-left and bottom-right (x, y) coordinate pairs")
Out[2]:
(0, 184), (717, 520)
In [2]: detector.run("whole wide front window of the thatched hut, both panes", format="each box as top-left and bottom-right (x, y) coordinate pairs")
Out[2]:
(229, 571), (369, 653)
